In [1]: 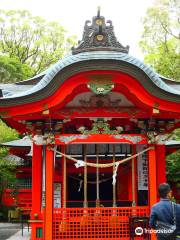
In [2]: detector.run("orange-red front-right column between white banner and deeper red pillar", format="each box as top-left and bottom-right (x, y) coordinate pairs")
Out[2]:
(149, 145), (157, 207)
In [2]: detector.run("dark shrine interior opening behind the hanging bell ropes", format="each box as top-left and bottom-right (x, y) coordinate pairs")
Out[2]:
(64, 143), (132, 207)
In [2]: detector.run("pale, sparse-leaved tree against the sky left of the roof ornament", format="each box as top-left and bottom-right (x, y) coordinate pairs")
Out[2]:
(0, 10), (75, 74)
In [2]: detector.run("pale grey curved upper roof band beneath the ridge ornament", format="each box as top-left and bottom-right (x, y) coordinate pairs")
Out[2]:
(1, 51), (180, 99)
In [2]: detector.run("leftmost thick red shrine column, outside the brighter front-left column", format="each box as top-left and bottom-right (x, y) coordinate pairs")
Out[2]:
(31, 143), (42, 240)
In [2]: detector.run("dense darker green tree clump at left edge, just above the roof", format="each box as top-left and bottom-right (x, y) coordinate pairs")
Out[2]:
(0, 56), (33, 83)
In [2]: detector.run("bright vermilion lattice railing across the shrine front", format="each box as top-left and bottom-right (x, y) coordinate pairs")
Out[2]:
(53, 207), (149, 240)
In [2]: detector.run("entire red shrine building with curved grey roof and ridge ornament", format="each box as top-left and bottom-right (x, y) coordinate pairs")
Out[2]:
(0, 11), (180, 240)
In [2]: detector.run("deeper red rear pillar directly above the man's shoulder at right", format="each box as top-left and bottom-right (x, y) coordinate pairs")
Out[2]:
(156, 145), (166, 187)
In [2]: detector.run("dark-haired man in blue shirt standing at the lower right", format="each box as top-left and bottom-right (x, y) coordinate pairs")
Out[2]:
(149, 183), (180, 240)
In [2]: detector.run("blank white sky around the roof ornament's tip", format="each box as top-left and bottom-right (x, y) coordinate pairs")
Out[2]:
(0, 0), (154, 60)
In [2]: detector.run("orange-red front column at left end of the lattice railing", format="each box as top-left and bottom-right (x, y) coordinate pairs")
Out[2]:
(44, 146), (54, 240)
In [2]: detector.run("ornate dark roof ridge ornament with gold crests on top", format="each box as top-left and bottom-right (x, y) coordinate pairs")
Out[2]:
(72, 8), (129, 54)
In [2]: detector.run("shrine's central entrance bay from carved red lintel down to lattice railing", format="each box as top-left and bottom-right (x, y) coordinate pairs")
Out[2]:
(52, 141), (153, 240)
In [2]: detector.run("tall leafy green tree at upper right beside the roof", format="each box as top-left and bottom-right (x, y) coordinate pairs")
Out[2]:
(140, 0), (180, 80)
